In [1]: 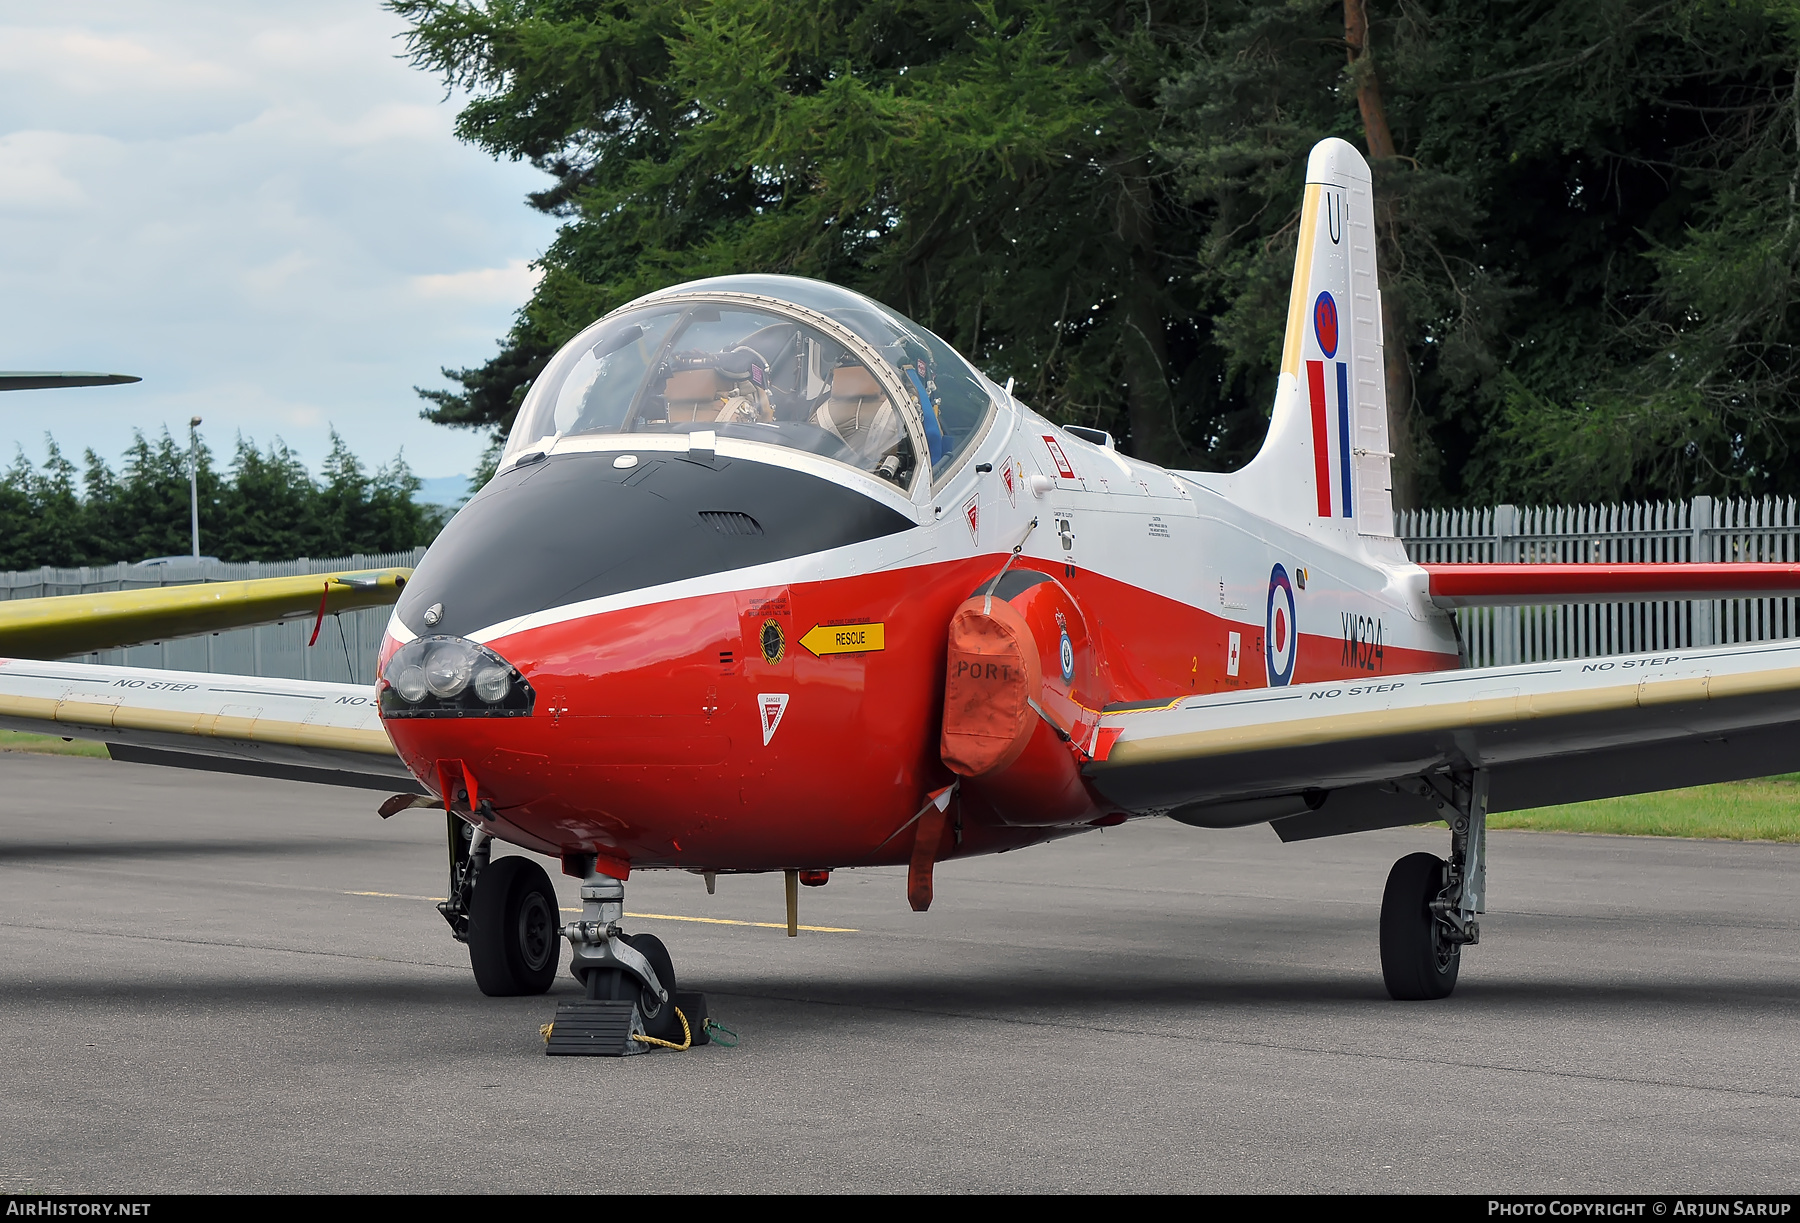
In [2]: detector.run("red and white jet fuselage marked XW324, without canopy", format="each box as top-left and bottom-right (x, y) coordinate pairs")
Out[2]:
(372, 369), (1458, 875)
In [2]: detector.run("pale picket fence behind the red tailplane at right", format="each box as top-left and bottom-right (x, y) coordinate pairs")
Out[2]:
(1399, 497), (1800, 666)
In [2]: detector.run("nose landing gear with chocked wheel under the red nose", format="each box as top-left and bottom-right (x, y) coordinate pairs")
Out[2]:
(544, 865), (702, 1057)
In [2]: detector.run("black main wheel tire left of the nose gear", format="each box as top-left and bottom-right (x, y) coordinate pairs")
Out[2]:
(468, 857), (562, 998)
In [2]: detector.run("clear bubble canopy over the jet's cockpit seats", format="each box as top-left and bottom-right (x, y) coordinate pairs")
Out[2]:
(500, 276), (994, 488)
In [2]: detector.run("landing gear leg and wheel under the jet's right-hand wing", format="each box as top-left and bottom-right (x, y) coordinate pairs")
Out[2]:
(1381, 769), (1487, 1001)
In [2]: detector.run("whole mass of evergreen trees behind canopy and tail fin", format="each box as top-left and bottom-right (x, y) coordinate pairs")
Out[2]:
(401, 0), (1800, 504)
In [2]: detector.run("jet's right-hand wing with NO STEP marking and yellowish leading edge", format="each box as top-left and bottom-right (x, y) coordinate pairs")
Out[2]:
(1085, 641), (1800, 841)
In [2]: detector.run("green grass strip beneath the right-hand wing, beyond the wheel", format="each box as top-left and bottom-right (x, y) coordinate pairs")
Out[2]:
(1487, 773), (1800, 841)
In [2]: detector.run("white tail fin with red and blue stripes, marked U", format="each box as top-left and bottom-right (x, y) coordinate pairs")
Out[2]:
(1229, 139), (1393, 537)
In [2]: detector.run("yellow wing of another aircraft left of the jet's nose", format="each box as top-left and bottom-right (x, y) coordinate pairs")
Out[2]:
(0, 569), (412, 657)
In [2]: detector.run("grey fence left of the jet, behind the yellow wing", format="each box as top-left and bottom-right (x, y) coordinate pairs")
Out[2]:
(0, 548), (425, 684)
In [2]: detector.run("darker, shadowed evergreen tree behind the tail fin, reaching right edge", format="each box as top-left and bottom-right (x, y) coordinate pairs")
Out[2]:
(1163, 0), (1800, 503)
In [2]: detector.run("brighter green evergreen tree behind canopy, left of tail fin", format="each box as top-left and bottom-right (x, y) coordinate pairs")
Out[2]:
(389, 0), (1204, 461)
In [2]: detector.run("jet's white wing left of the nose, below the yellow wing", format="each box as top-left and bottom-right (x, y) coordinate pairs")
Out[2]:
(0, 659), (425, 794)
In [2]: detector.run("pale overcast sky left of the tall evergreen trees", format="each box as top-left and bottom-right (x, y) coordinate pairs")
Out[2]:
(0, 0), (554, 477)
